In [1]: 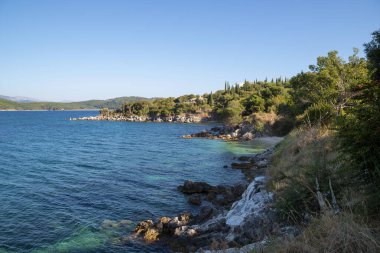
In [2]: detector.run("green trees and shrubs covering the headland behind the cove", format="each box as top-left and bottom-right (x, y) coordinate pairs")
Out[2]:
(118, 78), (290, 124)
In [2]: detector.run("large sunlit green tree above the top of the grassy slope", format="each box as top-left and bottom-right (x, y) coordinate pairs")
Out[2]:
(290, 49), (368, 124)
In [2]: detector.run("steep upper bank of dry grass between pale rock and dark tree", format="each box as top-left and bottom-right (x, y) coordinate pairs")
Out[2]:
(267, 127), (339, 223)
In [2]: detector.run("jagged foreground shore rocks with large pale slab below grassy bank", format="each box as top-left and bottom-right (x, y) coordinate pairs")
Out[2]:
(130, 148), (297, 252)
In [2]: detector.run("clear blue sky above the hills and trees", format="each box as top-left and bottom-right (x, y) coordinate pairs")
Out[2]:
(0, 0), (380, 101)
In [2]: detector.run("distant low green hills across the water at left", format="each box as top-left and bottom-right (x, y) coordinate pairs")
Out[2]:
(0, 96), (154, 110)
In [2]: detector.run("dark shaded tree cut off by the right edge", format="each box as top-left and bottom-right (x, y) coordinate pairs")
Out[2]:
(338, 30), (380, 214)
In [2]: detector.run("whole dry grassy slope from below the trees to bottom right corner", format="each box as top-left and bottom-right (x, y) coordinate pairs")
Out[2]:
(252, 127), (380, 253)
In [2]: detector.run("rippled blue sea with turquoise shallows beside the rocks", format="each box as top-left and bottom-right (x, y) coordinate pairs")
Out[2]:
(0, 111), (267, 253)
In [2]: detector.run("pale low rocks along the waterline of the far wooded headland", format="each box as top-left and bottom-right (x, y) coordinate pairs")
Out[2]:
(70, 114), (210, 123)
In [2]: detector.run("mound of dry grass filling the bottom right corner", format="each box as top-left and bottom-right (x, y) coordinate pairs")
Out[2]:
(262, 213), (380, 253)
